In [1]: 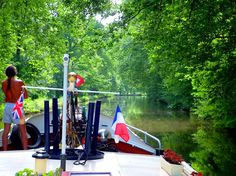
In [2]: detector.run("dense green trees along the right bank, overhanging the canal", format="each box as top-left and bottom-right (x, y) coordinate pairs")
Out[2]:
(116, 0), (236, 127)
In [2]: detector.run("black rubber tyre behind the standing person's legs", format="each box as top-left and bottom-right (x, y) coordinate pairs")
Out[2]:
(10, 123), (41, 150)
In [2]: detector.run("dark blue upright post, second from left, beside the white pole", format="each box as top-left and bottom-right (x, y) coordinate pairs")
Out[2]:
(52, 98), (59, 152)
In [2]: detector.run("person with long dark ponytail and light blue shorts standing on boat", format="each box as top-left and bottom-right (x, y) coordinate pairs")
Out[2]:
(2, 65), (28, 150)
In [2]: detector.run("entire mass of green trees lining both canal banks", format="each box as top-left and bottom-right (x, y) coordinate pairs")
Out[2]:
(0, 0), (236, 175)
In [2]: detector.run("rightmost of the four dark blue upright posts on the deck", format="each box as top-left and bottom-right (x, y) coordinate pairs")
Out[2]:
(91, 101), (101, 154)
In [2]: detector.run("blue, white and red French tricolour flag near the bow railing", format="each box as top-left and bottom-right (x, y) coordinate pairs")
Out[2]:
(112, 105), (130, 142)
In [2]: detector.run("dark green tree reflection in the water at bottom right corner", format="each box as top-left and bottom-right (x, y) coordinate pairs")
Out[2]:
(191, 126), (236, 176)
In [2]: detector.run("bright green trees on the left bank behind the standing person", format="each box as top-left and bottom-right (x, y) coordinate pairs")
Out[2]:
(0, 0), (112, 99)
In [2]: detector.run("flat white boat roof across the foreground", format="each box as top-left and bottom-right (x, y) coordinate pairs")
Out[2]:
(0, 150), (168, 176)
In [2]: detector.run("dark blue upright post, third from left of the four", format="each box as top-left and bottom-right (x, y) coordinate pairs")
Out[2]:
(85, 103), (94, 155)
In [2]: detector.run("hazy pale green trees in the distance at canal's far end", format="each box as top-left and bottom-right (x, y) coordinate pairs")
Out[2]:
(111, 36), (149, 94)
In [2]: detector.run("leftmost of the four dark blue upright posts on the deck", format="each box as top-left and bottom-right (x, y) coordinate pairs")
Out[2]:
(44, 100), (50, 153)
